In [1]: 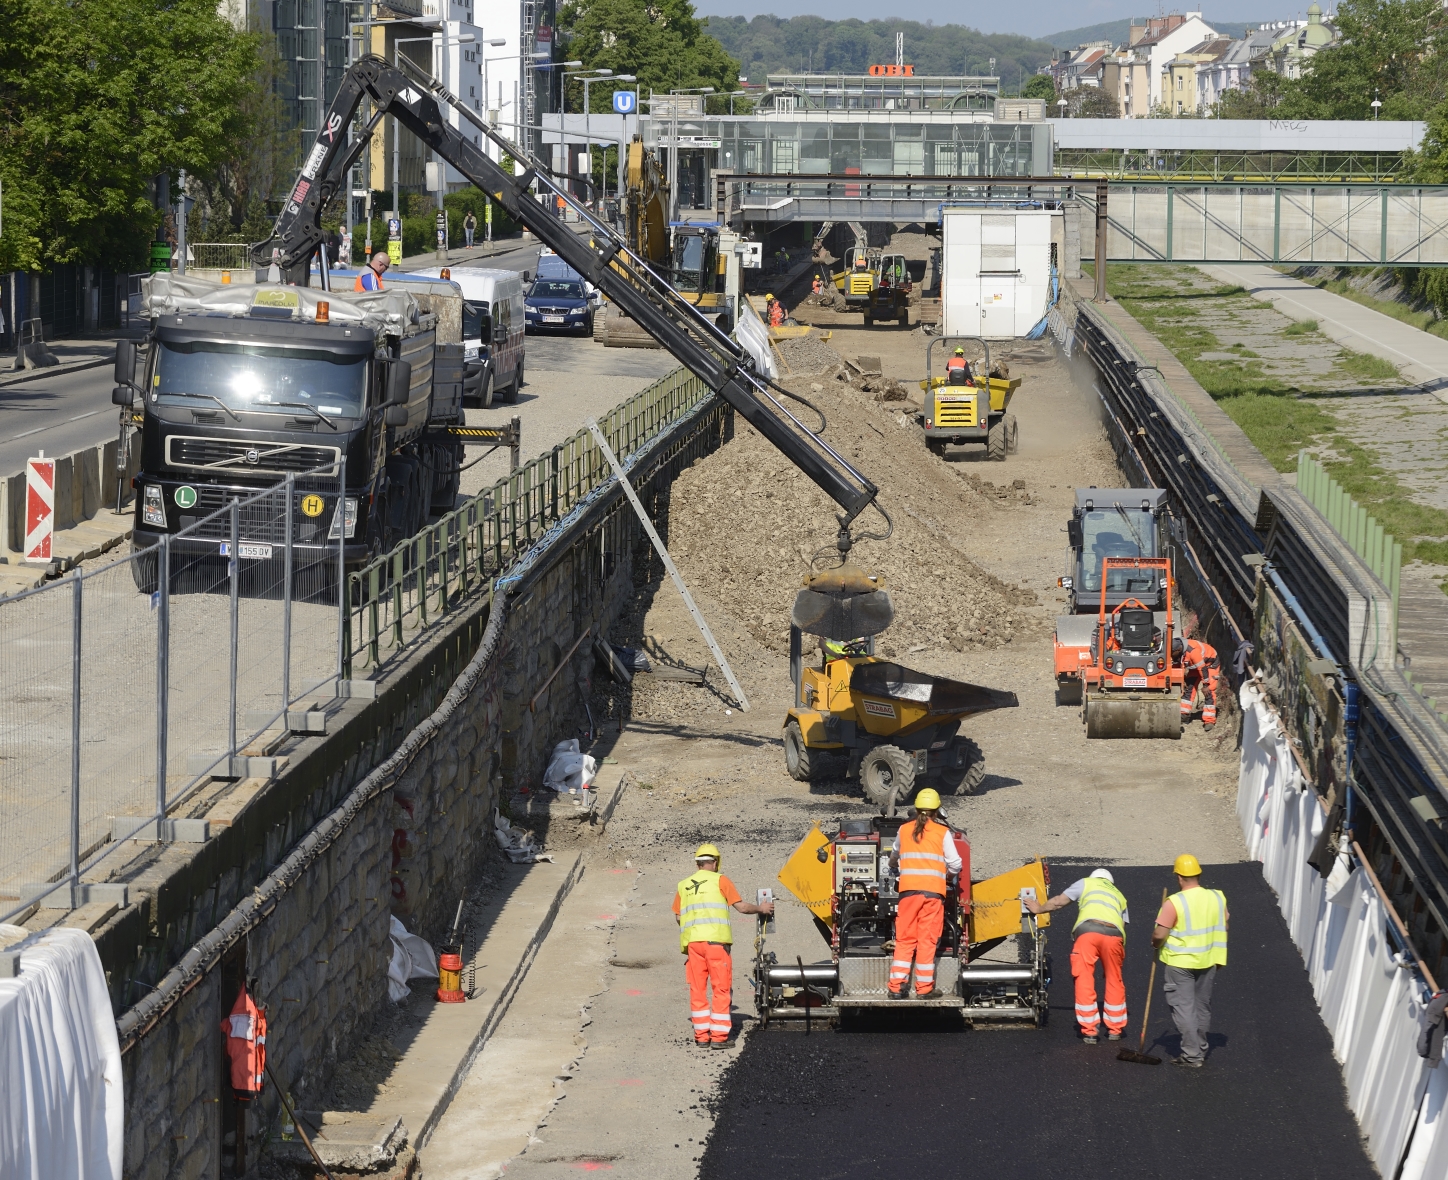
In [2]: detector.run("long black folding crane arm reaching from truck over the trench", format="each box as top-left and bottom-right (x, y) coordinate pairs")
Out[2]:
(253, 56), (877, 550)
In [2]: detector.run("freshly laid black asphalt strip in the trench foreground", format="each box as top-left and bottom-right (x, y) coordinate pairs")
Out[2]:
(699, 863), (1377, 1180)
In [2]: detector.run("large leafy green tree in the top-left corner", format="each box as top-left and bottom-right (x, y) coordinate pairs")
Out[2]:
(0, 0), (258, 271)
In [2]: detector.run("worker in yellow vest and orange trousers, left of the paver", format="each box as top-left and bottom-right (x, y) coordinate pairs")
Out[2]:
(673, 844), (775, 1048)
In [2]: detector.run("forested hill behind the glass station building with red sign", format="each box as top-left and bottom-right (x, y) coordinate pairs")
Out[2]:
(708, 16), (1054, 94)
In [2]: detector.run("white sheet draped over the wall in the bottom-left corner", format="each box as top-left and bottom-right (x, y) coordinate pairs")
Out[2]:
(0, 925), (125, 1180)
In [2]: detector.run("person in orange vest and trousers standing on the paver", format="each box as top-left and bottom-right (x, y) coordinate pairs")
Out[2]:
(889, 786), (963, 999)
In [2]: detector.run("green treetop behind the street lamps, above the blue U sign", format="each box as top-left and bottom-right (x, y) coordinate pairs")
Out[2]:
(557, 0), (738, 111)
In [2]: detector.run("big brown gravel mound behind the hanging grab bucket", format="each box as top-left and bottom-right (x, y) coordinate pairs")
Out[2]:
(669, 342), (1043, 657)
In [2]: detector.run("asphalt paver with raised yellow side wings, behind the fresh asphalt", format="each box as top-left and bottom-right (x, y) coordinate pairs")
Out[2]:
(753, 812), (1051, 1028)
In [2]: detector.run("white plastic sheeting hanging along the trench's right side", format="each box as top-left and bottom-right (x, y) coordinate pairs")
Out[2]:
(1237, 683), (1448, 1180)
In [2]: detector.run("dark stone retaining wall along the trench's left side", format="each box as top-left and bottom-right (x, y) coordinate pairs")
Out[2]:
(110, 382), (733, 1180)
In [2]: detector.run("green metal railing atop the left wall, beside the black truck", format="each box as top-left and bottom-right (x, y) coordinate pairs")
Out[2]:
(342, 369), (712, 679)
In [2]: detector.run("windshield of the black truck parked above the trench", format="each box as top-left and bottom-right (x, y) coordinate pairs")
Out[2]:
(151, 340), (366, 418)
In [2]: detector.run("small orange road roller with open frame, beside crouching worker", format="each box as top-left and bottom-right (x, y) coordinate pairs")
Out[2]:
(1080, 557), (1183, 738)
